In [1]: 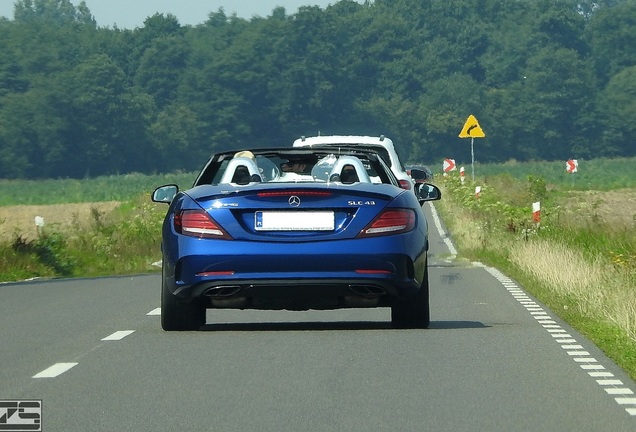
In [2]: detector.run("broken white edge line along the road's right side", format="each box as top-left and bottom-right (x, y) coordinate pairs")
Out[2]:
(473, 263), (636, 417)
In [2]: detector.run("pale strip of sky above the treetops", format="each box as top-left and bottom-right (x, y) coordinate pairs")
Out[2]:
(0, 0), (363, 29)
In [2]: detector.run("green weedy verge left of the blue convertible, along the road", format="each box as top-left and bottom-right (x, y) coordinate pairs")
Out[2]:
(0, 195), (167, 281)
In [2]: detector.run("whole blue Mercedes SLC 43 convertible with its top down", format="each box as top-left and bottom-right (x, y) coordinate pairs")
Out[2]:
(152, 147), (441, 331)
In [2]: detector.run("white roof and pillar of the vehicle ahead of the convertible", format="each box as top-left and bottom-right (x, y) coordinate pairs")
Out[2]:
(293, 135), (424, 190)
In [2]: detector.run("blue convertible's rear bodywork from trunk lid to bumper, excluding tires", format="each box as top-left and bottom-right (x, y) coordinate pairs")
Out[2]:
(163, 185), (426, 300)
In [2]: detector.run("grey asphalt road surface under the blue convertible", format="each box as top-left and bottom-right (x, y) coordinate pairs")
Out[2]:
(0, 206), (636, 432)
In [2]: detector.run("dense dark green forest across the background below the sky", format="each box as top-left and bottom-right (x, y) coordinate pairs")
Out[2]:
(0, 0), (636, 179)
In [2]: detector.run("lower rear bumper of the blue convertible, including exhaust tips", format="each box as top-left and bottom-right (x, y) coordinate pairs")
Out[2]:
(163, 241), (426, 310)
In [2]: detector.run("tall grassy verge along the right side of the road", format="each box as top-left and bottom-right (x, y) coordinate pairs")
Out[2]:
(436, 176), (636, 379)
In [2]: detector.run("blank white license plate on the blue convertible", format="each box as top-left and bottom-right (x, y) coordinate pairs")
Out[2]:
(254, 211), (335, 231)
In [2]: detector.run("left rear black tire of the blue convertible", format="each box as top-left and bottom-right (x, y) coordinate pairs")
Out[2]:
(161, 274), (206, 331)
